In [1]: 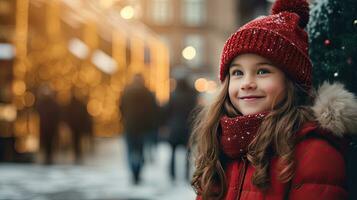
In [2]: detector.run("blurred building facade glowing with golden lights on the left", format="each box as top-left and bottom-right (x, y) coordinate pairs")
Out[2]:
(0, 0), (169, 161)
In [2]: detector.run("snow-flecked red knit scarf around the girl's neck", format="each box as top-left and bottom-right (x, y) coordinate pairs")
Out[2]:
(220, 112), (268, 159)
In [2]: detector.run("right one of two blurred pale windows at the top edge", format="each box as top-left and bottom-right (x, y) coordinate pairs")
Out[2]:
(182, 0), (206, 26)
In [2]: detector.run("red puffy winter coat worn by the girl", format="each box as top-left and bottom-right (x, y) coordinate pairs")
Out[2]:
(197, 123), (347, 200)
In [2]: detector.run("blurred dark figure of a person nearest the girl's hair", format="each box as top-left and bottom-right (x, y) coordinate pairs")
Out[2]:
(164, 78), (197, 181)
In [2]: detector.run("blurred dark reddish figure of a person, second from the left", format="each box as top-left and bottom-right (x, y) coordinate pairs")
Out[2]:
(66, 96), (93, 164)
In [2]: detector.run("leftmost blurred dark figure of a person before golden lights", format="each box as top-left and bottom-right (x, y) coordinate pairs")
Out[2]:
(36, 86), (61, 164)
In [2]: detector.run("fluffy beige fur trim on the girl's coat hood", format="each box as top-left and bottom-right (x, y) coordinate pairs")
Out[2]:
(312, 82), (357, 137)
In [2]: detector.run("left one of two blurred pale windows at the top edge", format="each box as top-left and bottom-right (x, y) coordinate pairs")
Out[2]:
(150, 0), (172, 25)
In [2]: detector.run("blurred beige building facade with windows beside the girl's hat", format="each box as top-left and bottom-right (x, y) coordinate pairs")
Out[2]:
(138, 0), (271, 81)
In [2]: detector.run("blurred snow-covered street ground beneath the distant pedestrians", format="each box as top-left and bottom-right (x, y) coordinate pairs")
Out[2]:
(0, 138), (195, 200)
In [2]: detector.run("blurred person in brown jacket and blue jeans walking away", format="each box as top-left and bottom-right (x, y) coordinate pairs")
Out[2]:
(120, 74), (158, 184)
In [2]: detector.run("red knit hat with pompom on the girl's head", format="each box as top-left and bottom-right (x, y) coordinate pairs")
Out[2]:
(220, 0), (312, 90)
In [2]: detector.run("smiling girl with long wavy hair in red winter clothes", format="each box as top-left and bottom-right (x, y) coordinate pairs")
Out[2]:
(192, 0), (357, 200)
